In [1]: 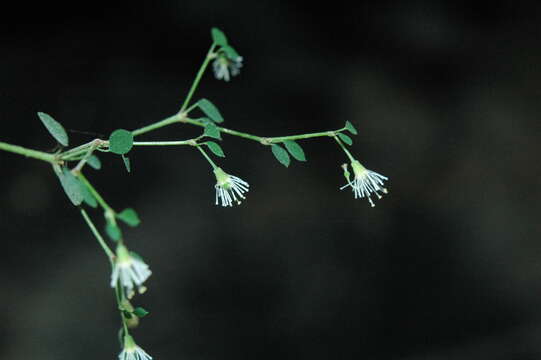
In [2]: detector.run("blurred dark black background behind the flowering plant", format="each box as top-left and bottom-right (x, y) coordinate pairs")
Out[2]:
(0, 0), (541, 360)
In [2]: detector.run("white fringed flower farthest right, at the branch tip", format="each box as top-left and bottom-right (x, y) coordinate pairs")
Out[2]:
(340, 160), (388, 207)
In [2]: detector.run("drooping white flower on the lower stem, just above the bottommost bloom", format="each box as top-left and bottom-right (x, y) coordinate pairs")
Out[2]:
(111, 245), (152, 297)
